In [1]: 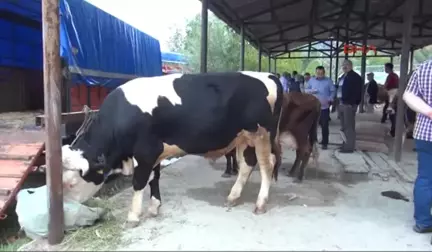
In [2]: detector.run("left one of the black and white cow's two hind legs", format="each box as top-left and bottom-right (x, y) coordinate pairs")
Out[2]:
(226, 143), (257, 207)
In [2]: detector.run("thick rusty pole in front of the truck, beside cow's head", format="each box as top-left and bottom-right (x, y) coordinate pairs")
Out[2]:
(42, 0), (64, 245)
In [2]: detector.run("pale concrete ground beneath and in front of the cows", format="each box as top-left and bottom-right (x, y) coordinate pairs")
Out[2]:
(109, 120), (432, 251)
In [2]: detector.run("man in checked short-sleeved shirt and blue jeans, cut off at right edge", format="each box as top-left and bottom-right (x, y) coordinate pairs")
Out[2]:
(403, 60), (432, 236)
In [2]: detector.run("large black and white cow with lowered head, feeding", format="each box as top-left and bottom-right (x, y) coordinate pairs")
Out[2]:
(62, 72), (283, 227)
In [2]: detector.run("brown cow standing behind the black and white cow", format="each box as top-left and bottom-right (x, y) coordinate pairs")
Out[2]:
(222, 92), (321, 182)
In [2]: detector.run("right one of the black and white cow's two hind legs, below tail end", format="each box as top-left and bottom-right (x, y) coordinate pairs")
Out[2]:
(254, 131), (276, 214)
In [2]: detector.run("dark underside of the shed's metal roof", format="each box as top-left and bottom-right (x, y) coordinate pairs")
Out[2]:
(205, 0), (432, 54)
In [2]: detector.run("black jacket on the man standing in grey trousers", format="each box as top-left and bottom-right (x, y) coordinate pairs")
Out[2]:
(338, 70), (364, 105)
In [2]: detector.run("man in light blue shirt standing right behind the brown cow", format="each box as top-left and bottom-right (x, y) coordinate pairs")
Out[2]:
(305, 66), (336, 150)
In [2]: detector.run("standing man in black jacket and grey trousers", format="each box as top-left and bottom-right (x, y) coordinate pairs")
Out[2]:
(337, 60), (363, 153)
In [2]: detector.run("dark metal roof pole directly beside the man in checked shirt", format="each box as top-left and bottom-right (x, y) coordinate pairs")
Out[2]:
(393, 1), (415, 162)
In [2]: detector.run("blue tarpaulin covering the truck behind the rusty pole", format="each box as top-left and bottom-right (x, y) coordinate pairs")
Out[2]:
(0, 0), (162, 87)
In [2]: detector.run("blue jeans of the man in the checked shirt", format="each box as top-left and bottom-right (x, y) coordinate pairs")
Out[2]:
(414, 139), (432, 228)
